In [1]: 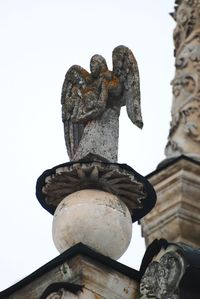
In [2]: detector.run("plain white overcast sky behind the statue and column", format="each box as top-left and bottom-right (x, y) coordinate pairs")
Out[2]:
(0, 0), (175, 290)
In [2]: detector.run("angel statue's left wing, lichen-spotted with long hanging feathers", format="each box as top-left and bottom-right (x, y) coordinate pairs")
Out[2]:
(61, 65), (89, 160)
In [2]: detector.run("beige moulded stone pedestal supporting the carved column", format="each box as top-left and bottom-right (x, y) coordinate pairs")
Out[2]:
(141, 157), (200, 247)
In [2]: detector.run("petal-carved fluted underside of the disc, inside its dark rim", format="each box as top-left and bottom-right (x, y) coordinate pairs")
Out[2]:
(42, 162), (147, 221)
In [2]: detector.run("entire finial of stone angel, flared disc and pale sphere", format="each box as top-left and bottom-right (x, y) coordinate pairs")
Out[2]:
(37, 46), (156, 259)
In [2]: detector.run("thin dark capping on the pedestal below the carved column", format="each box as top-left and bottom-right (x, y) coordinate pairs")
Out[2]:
(145, 155), (200, 179)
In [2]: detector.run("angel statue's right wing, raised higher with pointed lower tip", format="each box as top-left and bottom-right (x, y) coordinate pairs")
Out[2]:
(113, 46), (143, 128)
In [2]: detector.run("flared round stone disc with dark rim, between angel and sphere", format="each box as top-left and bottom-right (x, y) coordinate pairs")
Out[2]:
(36, 161), (156, 222)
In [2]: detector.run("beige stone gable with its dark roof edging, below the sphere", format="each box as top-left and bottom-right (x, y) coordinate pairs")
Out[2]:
(0, 243), (140, 299)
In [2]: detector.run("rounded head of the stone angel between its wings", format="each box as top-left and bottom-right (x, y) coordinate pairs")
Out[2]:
(90, 54), (108, 78)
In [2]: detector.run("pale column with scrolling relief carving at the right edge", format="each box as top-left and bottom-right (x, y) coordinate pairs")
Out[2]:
(165, 0), (200, 159)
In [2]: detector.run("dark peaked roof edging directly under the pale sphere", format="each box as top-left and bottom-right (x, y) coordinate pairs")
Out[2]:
(0, 243), (141, 299)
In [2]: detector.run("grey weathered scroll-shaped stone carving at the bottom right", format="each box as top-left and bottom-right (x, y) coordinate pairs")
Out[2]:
(139, 251), (185, 299)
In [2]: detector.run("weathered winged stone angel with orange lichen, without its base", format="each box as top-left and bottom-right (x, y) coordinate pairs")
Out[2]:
(61, 46), (143, 163)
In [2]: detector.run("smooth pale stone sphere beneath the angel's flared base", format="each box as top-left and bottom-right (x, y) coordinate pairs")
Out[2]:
(52, 189), (132, 259)
